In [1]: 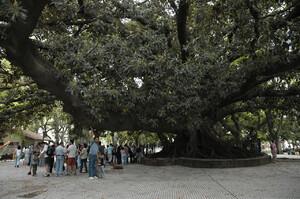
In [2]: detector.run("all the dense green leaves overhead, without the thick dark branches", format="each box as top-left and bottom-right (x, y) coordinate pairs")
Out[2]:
(0, 0), (300, 146)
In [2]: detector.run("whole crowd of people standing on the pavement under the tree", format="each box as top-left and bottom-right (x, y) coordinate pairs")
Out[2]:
(15, 129), (143, 179)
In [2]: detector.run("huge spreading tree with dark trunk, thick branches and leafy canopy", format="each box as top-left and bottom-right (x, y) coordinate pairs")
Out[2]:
(0, 0), (300, 157)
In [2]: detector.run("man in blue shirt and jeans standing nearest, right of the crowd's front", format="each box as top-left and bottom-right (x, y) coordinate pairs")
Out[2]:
(89, 128), (99, 180)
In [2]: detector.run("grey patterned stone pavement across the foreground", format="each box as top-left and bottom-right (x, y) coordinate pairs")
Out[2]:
(0, 159), (300, 199)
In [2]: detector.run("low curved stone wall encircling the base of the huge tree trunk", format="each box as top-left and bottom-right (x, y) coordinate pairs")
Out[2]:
(142, 155), (271, 168)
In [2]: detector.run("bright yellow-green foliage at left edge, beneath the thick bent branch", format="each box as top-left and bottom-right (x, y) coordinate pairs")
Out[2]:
(0, 59), (55, 135)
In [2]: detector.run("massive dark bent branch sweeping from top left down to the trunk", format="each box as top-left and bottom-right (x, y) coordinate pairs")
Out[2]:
(1, 0), (182, 132)
